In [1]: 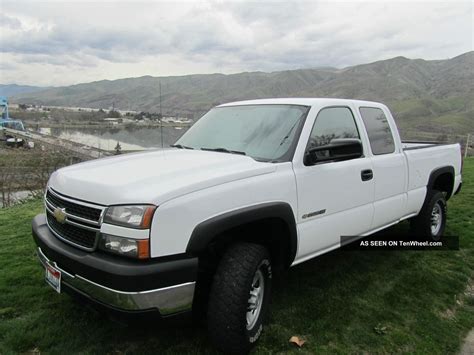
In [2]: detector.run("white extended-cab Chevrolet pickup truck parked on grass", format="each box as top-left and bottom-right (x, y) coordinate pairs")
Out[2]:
(33, 98), (462, 352)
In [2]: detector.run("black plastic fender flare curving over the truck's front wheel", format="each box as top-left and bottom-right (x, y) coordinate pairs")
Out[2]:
(186, 202), (298, 266)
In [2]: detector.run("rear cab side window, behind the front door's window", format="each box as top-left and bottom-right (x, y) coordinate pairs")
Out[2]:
(359, 107), (395, 155)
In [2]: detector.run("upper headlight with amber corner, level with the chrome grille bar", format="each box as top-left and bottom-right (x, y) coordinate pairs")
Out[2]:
(104, 205), (156, 229)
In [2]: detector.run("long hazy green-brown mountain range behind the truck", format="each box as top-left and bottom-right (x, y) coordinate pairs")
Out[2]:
(7, 51), (474, 138)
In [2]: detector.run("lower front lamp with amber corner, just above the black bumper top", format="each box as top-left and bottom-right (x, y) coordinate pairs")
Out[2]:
(99, 234), (150, 259)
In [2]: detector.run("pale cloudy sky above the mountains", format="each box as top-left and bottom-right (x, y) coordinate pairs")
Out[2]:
(0, 0), (474, 86)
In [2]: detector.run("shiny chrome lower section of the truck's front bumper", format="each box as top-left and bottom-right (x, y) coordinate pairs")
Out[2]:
(37, 248), (195, 316)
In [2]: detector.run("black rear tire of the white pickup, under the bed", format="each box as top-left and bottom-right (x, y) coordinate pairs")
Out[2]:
(411, 190), (447, 240)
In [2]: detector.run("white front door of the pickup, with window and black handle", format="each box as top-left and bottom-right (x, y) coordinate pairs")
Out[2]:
(293, 106), (374, 262)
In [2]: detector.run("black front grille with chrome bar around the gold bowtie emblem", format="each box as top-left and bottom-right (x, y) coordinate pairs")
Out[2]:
(45, 190), (102, 251)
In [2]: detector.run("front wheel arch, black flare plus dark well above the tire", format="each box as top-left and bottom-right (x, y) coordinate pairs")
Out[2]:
(186, 202), (298, 267)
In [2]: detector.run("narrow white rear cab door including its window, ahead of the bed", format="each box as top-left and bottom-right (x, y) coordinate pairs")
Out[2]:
(358, 106), (407, 229)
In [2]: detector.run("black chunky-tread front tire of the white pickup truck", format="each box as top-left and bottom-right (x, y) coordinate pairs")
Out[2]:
(207, 243), (272, 354)
